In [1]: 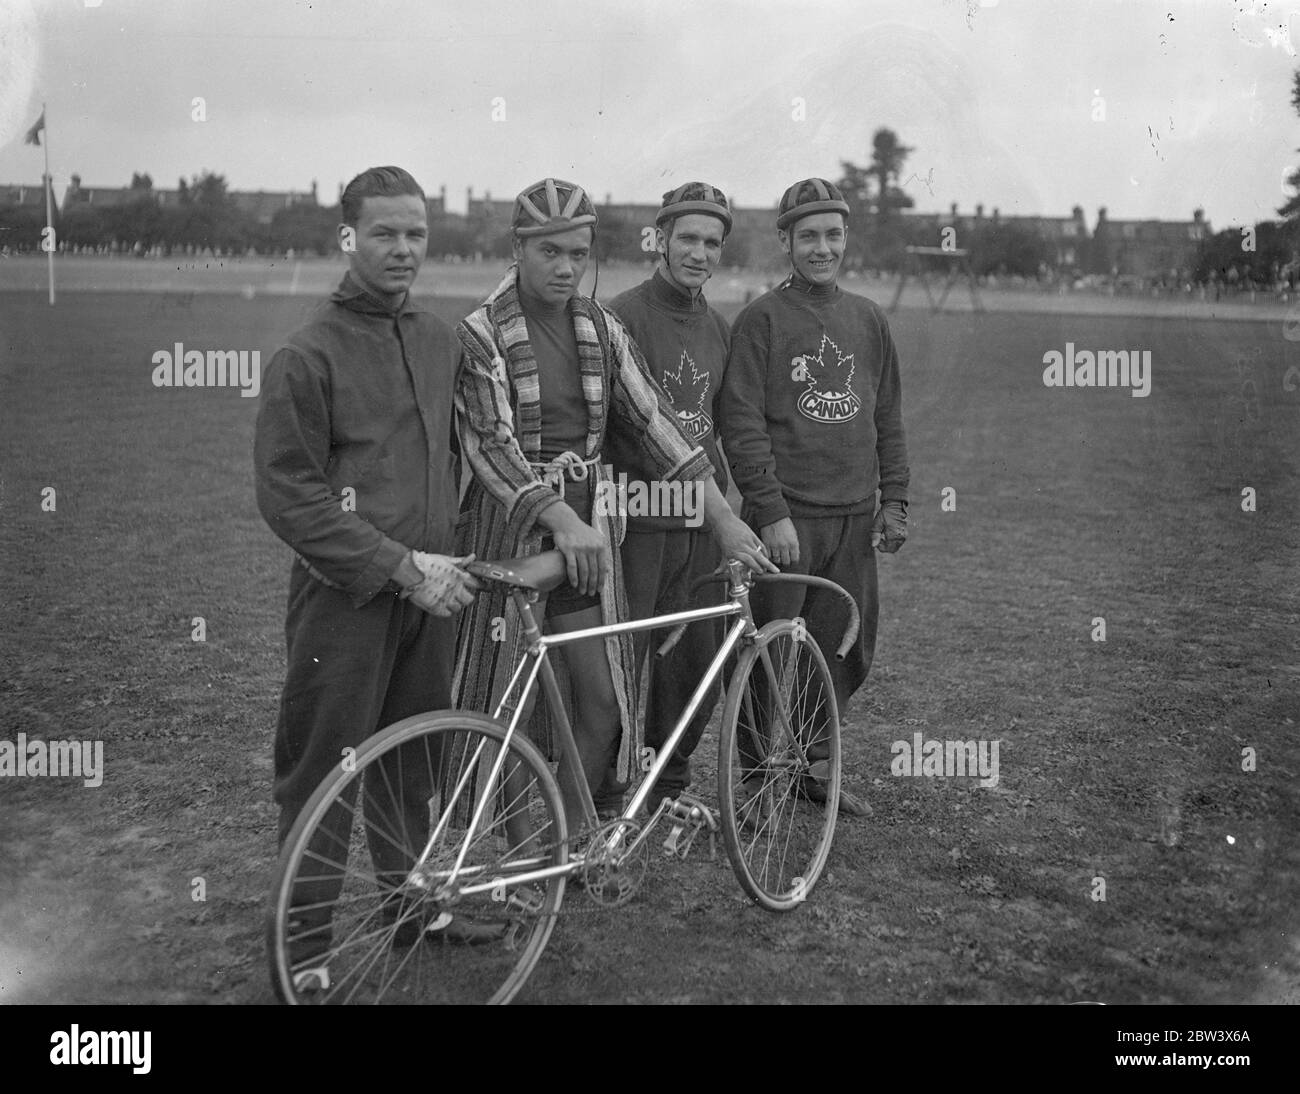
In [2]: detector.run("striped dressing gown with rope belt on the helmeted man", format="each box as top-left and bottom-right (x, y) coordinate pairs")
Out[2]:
(452, 266), (712, 780)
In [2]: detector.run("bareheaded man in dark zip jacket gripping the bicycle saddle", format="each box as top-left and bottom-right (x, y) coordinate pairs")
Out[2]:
(254, 168), (477, 987)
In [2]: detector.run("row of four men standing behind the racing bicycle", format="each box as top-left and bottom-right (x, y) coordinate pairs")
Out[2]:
(255, 168), (909, 930)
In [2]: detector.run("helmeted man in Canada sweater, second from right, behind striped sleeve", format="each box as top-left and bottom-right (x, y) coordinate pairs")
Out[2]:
(606, 182), (732, 808)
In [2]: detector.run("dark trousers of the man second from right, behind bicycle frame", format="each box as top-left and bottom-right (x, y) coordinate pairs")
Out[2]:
(623, 529), (725, 806)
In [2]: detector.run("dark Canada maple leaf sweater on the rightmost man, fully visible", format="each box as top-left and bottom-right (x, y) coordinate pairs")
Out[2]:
(718, 273), (910, 528)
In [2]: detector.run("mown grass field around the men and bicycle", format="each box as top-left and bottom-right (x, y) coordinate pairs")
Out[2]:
(0, 276), (1300, 1003)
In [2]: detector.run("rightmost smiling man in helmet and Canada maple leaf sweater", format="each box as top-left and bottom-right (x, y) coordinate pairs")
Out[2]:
(719, 178), (909, 815)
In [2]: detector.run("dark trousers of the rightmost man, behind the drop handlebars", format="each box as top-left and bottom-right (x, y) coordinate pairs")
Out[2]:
(750, 513), (880, 755)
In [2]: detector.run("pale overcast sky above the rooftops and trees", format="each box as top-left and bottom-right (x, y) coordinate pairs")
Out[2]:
(0, 0), (1300, 227)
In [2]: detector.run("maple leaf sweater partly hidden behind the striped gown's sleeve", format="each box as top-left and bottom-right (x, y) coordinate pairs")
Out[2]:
(605, 270), (728, 531)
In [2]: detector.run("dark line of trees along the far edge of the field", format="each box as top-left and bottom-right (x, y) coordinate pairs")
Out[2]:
(0, 126), (1300, 286)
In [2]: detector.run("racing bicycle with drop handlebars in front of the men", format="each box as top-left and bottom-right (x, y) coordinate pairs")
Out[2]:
(268, 551), (858, 1003)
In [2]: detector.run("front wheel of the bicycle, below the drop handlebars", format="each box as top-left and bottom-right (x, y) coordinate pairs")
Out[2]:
(718, 620), (840, 912)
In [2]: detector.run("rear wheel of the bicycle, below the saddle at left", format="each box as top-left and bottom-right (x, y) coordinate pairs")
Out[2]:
(267, 711), (568, 1003)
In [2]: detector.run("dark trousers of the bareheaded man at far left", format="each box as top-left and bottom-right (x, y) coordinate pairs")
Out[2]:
(274, 565), (456, 960)
